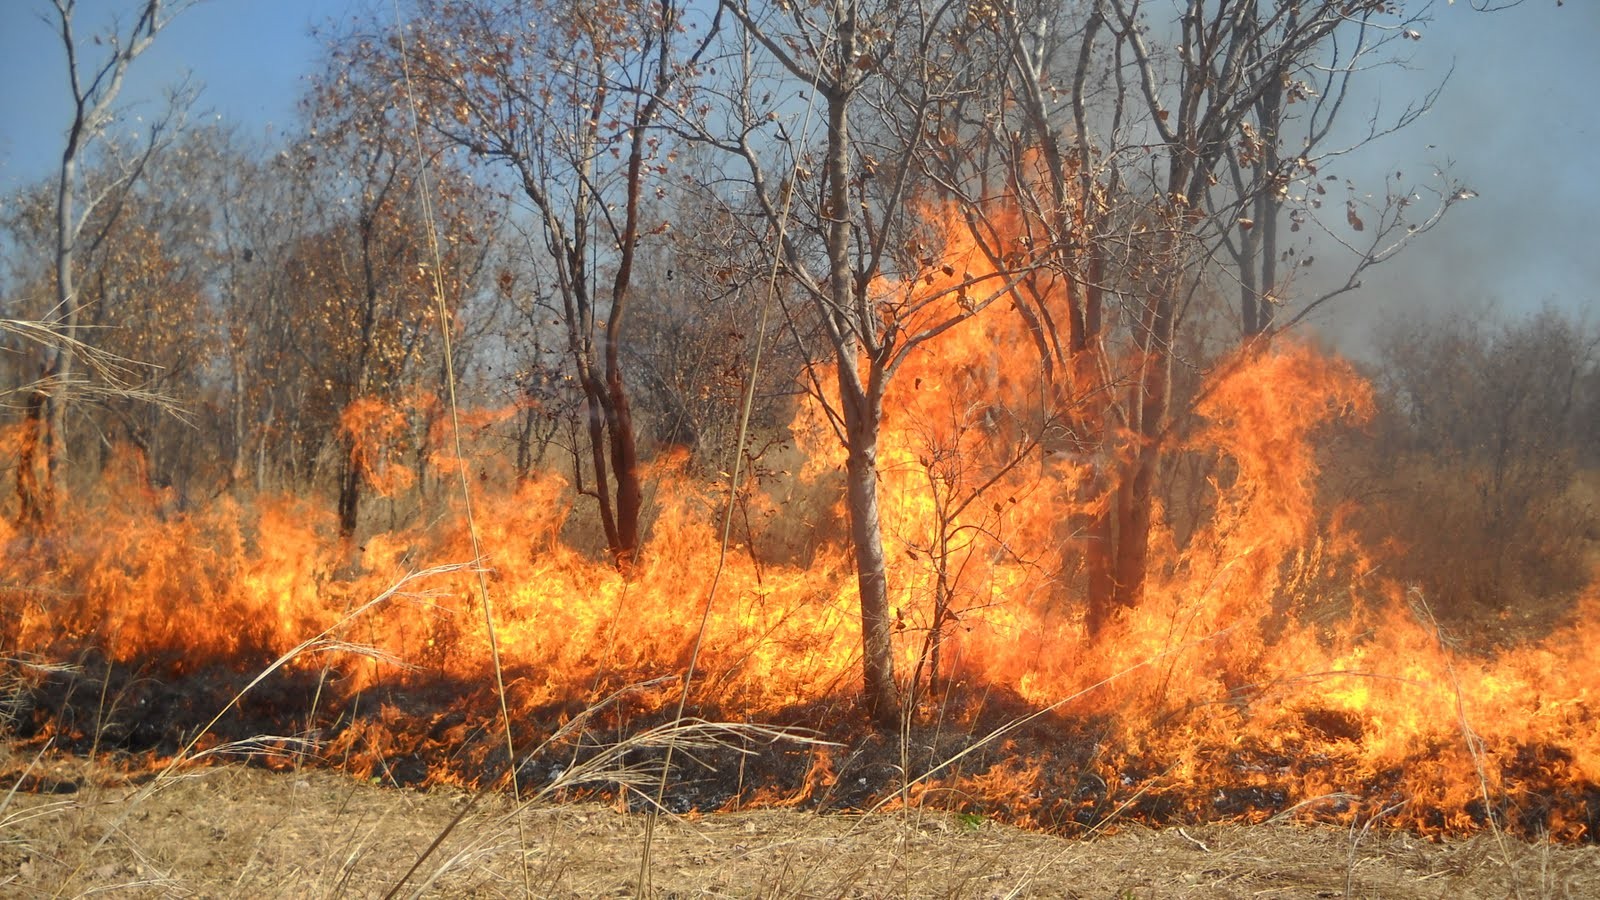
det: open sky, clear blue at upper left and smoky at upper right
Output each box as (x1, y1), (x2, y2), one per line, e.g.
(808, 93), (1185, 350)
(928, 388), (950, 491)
(0, 0), (1600, 343)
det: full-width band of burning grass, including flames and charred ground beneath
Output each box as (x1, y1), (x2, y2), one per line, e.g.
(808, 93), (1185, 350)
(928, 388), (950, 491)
(0, 335), (1600, 842)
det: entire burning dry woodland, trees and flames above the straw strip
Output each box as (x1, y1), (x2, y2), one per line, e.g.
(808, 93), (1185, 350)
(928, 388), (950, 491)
(0, 0), (1600, 895)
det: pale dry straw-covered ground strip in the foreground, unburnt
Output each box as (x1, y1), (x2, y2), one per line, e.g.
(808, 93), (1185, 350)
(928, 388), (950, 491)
(0, 751), (1600, 900)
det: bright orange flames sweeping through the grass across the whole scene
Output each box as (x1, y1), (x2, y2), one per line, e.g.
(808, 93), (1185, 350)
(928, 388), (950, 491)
(0, 203), (1600, 839)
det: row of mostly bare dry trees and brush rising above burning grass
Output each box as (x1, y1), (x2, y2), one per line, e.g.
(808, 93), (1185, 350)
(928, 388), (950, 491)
(0, 0), (1597, 721)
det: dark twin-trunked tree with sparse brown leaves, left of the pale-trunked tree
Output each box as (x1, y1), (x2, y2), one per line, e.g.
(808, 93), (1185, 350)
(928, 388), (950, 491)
(363, 0), (709, 569)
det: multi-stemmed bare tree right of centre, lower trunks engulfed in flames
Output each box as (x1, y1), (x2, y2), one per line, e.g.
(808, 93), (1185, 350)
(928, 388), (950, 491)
(923, 0), (1466, 633)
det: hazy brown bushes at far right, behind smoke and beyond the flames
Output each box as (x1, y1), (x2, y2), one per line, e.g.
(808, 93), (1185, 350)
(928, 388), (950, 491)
(1368, 309), (1600, 612)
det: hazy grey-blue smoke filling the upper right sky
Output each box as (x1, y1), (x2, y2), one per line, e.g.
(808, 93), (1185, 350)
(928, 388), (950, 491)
(1299, 0), (1600, 356)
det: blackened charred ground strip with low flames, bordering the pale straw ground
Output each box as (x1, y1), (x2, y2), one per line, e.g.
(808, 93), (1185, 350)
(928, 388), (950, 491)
(5, 657), (1600, 842)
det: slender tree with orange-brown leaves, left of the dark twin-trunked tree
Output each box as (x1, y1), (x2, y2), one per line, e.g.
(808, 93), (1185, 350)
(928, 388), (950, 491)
(290, 61), (498, 536)
